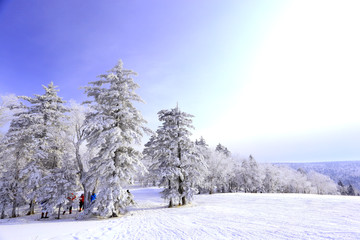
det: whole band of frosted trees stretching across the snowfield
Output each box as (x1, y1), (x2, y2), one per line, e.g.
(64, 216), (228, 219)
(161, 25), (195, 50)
(0, 61), (356, 218)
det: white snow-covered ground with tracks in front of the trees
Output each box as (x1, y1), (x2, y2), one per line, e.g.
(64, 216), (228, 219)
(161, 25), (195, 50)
(0, 188), (360, 240)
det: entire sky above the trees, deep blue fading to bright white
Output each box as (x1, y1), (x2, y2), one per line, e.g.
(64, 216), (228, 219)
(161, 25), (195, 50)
(0, 0), (360, 162)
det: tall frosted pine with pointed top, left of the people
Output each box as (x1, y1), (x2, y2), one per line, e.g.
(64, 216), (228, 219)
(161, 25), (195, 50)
(21, 82), (67, 216)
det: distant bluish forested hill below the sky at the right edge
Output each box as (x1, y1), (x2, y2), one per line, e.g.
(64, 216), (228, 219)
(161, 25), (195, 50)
(285, 161), (360, 190)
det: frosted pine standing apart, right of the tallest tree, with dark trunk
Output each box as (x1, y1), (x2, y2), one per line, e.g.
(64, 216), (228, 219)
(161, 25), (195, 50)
(144, 107), (205, 207)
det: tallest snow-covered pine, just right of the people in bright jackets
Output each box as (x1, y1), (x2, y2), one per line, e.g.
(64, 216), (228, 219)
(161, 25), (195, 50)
(85, 60), (151, 217)
